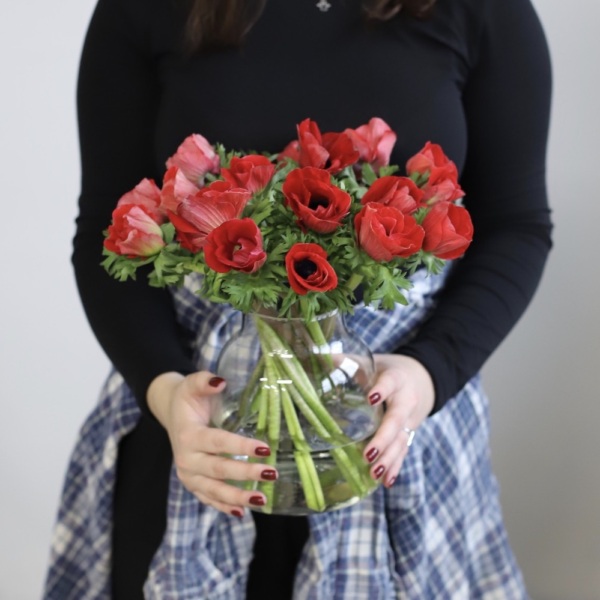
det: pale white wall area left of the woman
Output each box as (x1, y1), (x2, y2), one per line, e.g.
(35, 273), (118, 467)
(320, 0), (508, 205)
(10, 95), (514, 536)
(0, 0), (107, 600)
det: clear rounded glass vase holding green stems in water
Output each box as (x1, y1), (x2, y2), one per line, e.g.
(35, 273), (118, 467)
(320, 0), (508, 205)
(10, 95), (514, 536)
(213, 312), (382, 515)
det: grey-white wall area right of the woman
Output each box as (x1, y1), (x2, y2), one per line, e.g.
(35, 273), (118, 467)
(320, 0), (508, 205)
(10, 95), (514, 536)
(484, 0), (600, 600)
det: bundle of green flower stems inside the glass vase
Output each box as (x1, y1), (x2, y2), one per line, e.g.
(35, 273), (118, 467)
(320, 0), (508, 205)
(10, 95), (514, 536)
(236, 314), (374, 512)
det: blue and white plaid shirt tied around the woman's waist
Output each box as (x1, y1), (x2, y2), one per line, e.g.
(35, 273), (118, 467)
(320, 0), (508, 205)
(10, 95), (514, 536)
(44, 273), (528, 600)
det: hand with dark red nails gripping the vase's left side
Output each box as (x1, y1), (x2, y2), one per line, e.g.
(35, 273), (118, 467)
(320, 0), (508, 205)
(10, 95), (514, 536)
(147, 371), (277, 517)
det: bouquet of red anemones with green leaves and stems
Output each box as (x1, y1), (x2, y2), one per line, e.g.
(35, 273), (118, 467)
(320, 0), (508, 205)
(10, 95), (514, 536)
(103, 118), (473, 511)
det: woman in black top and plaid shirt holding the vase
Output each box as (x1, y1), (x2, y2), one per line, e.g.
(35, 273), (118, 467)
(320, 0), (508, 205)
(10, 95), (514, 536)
(45, 0), (551, 600)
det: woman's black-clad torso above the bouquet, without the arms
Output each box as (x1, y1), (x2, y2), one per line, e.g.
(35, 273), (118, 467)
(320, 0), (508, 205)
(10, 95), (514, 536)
(129, 0), (481, 177)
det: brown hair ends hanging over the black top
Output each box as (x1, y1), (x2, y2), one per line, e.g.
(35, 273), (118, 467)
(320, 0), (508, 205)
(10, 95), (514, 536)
(186, 0), (436, 52)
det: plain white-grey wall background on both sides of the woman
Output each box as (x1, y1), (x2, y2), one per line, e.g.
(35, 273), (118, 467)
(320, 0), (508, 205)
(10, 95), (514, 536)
(0, 0), (600, 600)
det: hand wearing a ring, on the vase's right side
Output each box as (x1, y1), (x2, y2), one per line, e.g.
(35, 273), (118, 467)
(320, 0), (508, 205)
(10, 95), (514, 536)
(364, 354), (435, 487)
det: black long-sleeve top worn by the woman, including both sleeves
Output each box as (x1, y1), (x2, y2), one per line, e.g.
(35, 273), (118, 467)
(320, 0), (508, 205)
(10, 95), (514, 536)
(73, 0), (551, 410)
